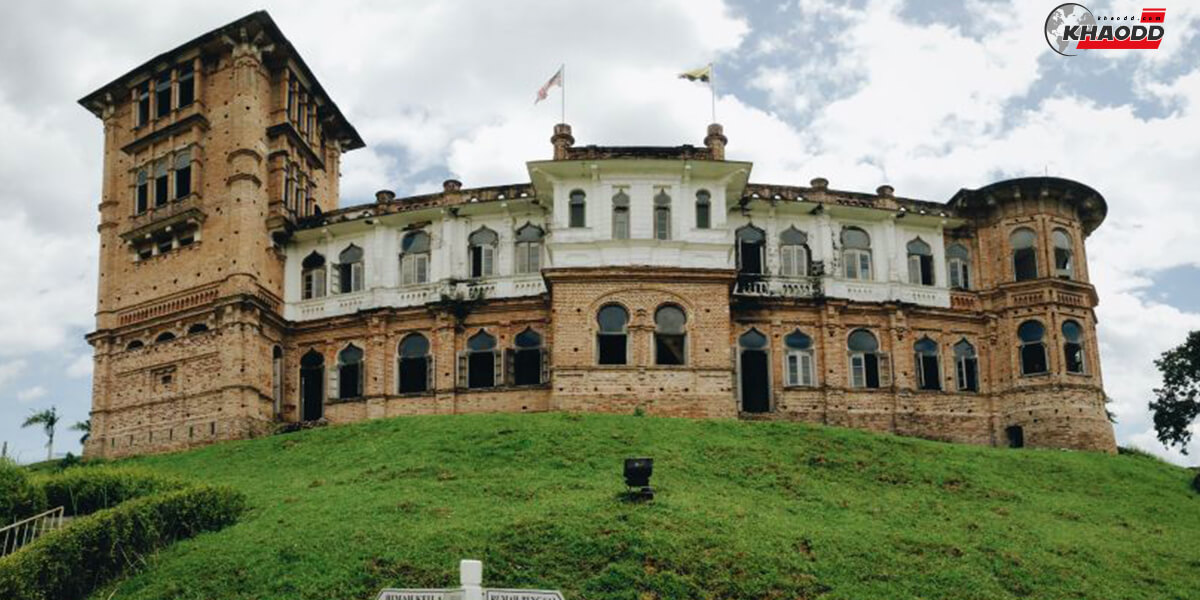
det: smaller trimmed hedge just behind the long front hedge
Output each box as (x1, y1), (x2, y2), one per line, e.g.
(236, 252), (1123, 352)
(37, 467), (185, 515)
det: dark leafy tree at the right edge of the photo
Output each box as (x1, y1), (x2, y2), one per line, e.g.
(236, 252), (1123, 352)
(1150, 331), (1200, 454)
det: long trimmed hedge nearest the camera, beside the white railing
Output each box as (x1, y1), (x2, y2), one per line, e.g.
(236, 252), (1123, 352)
(0, 486), (246, 600)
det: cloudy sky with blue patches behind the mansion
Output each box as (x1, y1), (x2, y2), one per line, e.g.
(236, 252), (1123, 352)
(0, 0), (1200, 463)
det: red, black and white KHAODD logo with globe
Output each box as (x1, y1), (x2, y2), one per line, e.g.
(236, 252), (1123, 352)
(1046, 2), (1166, 56)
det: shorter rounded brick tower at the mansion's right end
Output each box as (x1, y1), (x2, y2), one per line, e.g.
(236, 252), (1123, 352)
(947, 178), (1116, 449)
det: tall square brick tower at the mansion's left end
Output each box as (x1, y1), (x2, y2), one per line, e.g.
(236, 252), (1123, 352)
(79, 12), (362, 456)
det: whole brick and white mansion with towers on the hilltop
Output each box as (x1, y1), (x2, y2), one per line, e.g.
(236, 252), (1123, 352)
(80, 12), (1115, 456)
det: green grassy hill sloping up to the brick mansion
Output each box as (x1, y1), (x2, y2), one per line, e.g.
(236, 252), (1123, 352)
(94, 414), (1200, 600)
